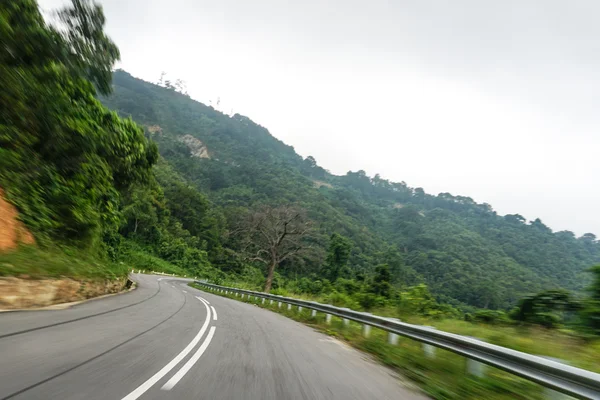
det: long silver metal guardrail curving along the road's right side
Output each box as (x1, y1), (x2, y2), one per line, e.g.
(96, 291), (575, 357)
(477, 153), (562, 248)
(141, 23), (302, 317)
(195, 281), (600, 400)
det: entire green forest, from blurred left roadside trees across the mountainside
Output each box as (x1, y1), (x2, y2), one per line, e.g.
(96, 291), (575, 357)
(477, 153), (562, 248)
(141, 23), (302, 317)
(0, 0), (600, 328)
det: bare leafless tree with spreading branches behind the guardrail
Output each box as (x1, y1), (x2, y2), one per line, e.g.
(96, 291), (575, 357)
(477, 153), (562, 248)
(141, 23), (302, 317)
(236, 206), (312, 293)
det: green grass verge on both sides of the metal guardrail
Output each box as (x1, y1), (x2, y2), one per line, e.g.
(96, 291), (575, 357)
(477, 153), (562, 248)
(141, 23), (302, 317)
(190, 283), (600, 400)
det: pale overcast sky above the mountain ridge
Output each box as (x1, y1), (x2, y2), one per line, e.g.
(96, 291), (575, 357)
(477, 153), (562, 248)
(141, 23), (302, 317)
(40, 0), (600, 234)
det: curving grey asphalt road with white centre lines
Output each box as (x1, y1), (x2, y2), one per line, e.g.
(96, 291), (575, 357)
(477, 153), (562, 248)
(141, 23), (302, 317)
(0, 275), (424, 400)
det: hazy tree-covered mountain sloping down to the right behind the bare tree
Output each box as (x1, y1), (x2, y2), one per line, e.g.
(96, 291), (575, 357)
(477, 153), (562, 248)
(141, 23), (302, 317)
(101, 71), (600, 308)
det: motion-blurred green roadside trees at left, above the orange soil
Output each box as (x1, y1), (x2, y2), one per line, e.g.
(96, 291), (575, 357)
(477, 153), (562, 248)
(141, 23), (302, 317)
(0, 0), (158, 247)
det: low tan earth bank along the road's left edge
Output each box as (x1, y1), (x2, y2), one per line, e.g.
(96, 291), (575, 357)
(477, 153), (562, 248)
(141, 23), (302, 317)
(0, 278), (127, 310)
